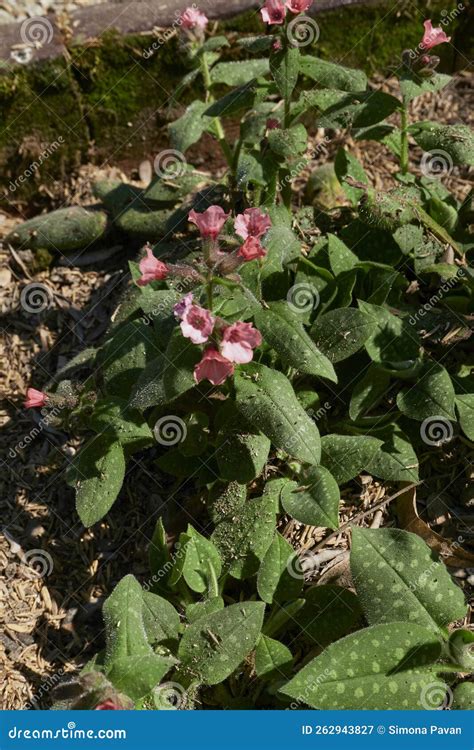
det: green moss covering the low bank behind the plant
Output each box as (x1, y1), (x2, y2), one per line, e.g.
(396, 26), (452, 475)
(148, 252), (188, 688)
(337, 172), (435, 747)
(0, 0), (474, 210)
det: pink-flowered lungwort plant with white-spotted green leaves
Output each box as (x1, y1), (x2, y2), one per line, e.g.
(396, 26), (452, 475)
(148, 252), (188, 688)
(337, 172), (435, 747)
(19, 0), (474, 710)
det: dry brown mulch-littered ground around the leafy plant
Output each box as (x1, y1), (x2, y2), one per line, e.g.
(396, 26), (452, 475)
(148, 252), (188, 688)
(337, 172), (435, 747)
(0, 73), (474, 709)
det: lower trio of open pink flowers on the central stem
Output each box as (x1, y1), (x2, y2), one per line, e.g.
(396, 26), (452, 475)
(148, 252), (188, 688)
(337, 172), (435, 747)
(174, 293), (262, 385)
